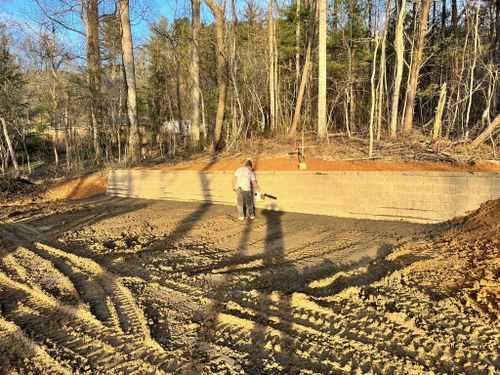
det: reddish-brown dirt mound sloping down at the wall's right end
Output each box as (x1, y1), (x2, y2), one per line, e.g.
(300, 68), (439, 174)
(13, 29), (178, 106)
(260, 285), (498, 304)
(391, 200), (500, 320)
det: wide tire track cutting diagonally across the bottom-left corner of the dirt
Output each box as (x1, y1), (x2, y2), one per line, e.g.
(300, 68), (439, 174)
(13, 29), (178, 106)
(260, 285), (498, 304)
(0, 273), (178, 373)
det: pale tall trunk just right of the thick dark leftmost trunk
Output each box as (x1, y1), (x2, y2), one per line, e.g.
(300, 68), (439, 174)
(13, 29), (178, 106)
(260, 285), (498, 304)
(119, 0), (141, 162)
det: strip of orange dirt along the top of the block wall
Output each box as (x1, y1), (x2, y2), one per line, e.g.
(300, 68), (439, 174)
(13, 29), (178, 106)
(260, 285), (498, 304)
(137, 157), (500, 172)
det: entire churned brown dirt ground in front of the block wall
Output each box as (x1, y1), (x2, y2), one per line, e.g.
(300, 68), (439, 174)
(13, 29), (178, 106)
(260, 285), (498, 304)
(0, 196), (500, 374)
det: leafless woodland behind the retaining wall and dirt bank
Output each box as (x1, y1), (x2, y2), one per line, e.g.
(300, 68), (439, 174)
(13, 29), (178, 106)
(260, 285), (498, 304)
(0, 0), (500, 173)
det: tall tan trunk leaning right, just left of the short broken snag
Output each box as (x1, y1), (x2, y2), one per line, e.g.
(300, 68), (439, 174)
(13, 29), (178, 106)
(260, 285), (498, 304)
(403, 0), (432, 133)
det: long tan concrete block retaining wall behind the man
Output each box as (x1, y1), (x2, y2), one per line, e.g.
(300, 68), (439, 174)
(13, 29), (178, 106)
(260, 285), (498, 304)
(107, 169), (500, 223)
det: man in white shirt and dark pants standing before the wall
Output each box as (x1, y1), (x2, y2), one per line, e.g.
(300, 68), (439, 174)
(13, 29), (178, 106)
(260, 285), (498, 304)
(233, 160), (260, 220)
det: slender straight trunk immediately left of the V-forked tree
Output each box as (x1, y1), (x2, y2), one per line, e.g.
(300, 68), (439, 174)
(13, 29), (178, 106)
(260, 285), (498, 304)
(189, 0), (200, 148)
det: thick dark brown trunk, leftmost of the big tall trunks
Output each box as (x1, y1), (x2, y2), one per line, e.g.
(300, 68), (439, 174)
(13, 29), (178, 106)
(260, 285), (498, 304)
(81, 0), (102, 162)
